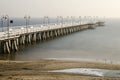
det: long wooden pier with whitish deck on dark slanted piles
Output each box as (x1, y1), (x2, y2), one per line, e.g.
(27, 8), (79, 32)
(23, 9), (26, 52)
(0, 22), (104, 54)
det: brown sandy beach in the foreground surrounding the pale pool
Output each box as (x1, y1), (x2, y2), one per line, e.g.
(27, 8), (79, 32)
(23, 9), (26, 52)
(0, 60), (120, 80)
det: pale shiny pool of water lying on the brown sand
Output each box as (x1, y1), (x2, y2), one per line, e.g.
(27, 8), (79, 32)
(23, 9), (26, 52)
(43, 68), (120, 77)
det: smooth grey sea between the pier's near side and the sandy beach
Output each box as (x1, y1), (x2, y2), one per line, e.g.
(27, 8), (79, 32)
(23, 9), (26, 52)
(1, 19), (120, 63)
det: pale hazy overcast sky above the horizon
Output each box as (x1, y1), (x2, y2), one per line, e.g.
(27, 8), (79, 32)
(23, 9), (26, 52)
(0, 0), (120, 17)
